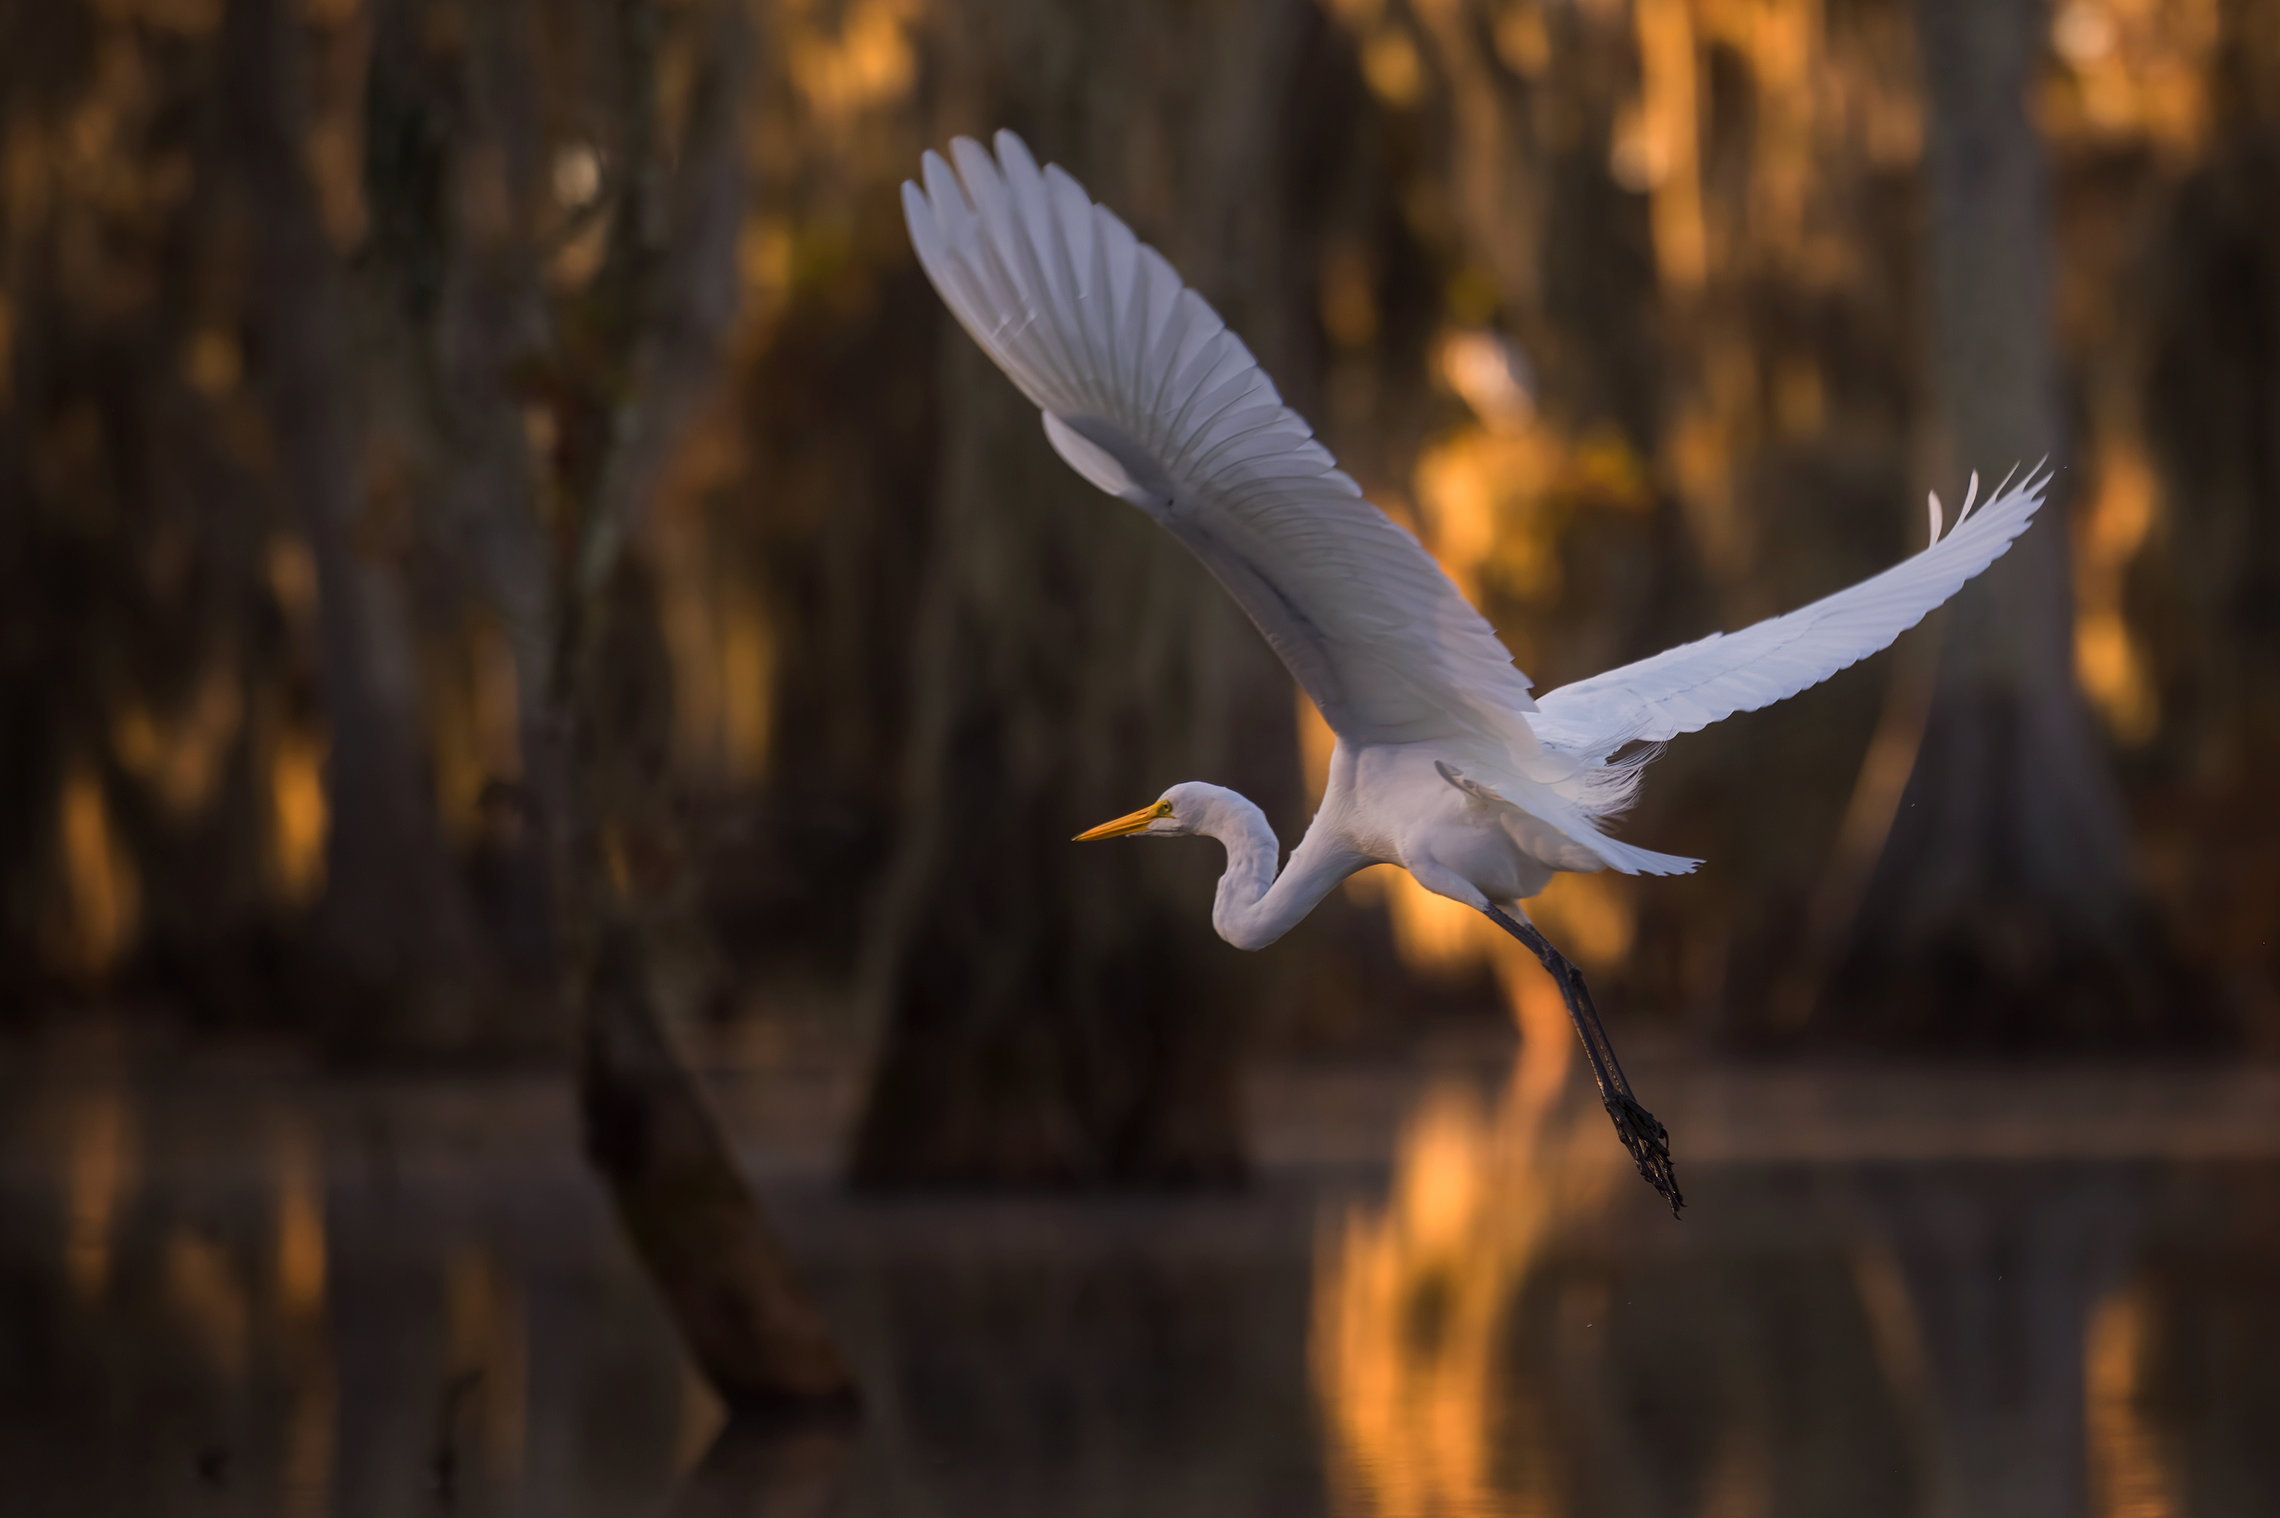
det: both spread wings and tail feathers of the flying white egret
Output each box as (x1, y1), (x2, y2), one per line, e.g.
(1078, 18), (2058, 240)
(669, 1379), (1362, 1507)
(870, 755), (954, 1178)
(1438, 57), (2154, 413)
(903, 132), (2047, 888)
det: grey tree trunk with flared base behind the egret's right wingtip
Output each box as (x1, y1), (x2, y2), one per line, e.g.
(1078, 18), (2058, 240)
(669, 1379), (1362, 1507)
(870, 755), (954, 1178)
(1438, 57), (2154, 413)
(1831, 0), (2161, 1046)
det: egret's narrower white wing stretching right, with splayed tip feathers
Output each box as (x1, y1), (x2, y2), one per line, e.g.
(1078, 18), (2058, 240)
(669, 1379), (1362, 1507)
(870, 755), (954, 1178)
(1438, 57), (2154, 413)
(1530, 470), (2050, 761)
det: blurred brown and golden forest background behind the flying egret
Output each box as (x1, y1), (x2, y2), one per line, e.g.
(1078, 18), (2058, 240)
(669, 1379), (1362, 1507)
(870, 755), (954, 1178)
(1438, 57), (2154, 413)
(0, 0), (2280, 1153)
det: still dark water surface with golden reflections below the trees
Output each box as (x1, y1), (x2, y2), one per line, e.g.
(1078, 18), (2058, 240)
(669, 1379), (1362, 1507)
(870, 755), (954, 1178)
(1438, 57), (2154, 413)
(0, 1030), (2280, 1518)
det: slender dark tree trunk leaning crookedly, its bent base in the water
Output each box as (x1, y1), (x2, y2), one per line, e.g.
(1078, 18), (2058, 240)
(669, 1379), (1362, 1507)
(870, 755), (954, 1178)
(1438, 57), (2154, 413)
(374, 0), (853, 1409)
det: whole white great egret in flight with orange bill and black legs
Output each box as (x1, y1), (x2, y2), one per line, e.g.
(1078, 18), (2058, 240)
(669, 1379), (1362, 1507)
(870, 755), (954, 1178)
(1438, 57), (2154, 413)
(903, 132), (2050, 1213)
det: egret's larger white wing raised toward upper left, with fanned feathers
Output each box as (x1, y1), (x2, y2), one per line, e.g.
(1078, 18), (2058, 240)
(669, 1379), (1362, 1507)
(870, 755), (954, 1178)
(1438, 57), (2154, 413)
(903, 132), (1534, 752)
